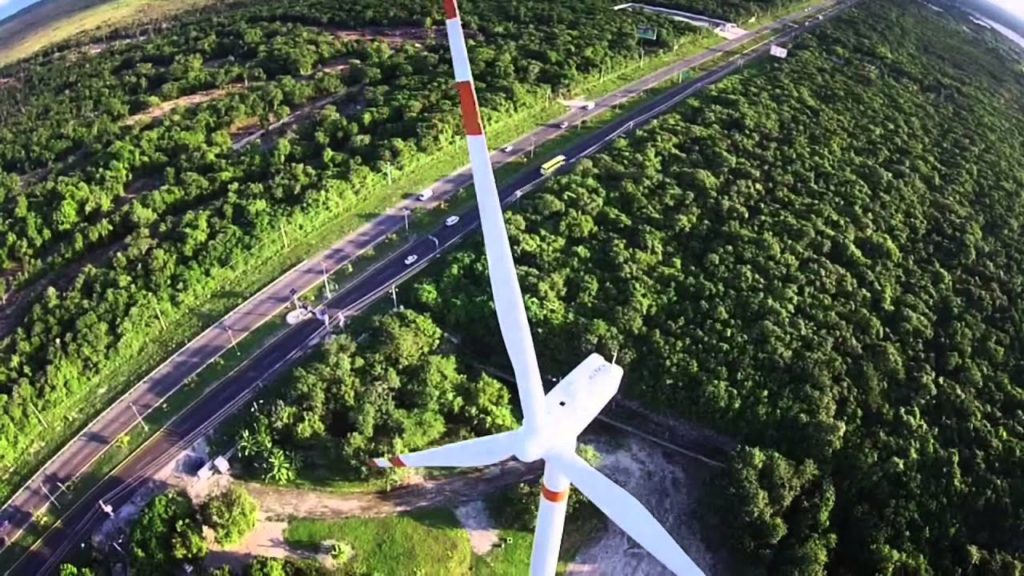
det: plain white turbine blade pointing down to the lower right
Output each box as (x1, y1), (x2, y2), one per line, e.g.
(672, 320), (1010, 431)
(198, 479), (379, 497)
(547, 454), (703, 575)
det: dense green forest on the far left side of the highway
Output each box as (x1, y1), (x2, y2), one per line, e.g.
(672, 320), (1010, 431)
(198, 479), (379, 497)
(0, 0), (720, 497)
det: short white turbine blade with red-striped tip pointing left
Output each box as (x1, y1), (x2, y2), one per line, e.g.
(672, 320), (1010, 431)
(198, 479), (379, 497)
(370, 430), (519, 468)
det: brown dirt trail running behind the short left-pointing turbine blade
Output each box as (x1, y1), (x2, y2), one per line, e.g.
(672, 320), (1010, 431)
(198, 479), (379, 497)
(245, 461), (542, 519)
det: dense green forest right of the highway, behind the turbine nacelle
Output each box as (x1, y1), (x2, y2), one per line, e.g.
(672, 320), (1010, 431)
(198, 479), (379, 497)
(405, 0), (1024, 574)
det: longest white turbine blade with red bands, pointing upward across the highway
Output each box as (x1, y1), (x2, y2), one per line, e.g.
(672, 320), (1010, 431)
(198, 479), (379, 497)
(444, 0), (544, 430)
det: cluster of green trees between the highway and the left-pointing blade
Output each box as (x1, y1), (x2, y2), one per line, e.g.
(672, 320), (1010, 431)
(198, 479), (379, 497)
(237, 311), (517, 484)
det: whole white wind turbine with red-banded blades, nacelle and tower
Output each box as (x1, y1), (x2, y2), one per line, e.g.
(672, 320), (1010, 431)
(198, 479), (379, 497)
(372, 0), (702, 576)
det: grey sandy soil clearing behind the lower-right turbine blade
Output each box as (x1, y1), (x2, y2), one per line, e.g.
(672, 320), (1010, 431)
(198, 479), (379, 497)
(566, 437), (717, 576)
